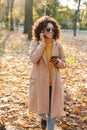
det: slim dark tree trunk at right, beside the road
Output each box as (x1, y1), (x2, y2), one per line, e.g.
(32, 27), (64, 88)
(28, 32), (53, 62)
(74, 0), (81, 36)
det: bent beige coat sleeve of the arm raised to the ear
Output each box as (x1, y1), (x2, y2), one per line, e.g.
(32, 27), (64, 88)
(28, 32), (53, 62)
(29, 40), (46, 63)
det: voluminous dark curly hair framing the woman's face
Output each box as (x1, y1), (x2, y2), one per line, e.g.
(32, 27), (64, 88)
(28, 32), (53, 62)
(32, 16), (60, 41)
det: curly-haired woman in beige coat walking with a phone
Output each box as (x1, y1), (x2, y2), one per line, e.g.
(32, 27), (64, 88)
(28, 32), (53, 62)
(29, 16), (66, 130)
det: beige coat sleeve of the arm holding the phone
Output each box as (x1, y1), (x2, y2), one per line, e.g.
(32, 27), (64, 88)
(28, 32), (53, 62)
(56, 44), (66, 69)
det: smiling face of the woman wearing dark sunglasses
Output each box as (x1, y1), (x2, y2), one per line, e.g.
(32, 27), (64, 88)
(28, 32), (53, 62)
(44, 23), (54, 38)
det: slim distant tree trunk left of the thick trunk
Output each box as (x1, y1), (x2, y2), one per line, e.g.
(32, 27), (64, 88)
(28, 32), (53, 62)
(10, 0), (14, 31)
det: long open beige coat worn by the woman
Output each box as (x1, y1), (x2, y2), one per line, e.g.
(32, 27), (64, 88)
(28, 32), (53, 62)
(29, 40), (66, 118)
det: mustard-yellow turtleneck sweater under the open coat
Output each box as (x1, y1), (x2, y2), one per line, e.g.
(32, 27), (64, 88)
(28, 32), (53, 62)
(45, 38), (53, 86)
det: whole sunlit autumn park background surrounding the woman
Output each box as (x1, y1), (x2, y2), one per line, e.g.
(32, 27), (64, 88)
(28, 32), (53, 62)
(0, 0), (87, 130)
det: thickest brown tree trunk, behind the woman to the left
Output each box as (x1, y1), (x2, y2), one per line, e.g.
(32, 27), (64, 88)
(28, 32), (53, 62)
(24, 0), (33, 39)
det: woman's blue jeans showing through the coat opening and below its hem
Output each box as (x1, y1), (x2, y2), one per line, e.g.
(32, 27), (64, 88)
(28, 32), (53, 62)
(42, 86), (55, 130)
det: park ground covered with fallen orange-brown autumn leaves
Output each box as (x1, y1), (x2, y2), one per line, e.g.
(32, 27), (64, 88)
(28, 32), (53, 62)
(0, 31), (87, 130)
